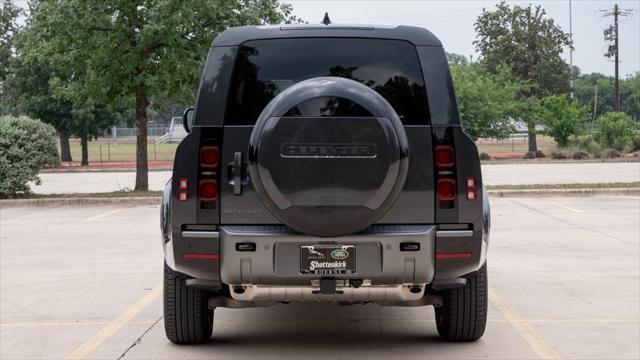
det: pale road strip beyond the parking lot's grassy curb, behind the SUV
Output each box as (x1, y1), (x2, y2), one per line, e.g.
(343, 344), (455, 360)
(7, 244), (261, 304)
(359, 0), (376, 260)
(31, 162), (640, 194)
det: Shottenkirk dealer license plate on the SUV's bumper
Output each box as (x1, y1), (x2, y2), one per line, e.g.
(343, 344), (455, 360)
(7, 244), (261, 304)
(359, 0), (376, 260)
(300, 244), (356, 275)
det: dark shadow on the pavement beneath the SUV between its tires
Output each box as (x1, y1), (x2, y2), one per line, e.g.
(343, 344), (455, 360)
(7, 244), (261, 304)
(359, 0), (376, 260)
(198, 303), (482, 359)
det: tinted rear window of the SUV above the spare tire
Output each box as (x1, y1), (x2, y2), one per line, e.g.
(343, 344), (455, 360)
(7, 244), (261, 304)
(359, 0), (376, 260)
(225, 38), (429, 125)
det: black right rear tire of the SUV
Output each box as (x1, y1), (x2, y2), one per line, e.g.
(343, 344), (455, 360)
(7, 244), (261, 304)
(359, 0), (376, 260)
(435, 263), (488, 341)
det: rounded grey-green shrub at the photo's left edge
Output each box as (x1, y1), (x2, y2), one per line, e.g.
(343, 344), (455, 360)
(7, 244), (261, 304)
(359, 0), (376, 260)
(0, 116), (58, 196)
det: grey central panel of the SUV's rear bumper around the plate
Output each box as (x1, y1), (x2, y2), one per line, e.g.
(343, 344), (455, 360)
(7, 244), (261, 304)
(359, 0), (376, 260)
(219, 225), (436, 286)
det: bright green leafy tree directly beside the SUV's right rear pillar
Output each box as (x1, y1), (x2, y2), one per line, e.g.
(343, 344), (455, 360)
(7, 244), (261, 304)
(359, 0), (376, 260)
(451, 64), (522, 140)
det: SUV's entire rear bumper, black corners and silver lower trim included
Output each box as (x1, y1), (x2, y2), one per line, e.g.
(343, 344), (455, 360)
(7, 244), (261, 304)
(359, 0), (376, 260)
(163, 224), (488, 302)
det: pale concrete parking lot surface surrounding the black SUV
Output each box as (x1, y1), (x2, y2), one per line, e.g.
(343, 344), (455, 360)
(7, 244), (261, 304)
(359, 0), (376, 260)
(0, 196), (640, 359)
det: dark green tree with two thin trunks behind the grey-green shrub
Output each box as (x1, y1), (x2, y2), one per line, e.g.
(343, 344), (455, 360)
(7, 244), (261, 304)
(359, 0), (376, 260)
(6, 2), (121, 165)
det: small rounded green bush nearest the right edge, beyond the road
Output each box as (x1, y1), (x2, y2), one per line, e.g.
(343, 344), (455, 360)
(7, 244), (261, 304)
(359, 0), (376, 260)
(597, 112), (634, 151)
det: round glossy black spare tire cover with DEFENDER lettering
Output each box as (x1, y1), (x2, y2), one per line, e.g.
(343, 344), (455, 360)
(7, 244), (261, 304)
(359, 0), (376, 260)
(248, 77), (409, 236)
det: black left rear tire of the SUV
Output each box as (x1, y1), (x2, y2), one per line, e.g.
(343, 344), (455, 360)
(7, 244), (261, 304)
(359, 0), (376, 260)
(164, 263), (213, 344)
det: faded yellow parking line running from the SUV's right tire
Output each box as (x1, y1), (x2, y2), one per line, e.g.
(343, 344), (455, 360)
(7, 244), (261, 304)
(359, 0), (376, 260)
(489, 288), (560, 359)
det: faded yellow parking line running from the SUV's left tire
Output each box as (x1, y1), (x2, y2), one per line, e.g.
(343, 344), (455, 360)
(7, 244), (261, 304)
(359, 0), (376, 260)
(66, 284), (162, 359)
